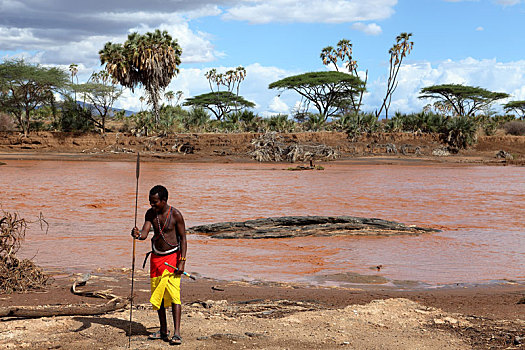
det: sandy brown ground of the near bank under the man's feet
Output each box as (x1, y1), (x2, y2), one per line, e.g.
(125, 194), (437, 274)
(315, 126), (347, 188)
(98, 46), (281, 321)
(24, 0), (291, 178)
(0, 269), (525, 350)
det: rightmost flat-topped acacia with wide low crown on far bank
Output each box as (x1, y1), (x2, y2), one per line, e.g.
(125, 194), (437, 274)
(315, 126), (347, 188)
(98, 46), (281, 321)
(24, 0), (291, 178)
(419, 84), (509, 117)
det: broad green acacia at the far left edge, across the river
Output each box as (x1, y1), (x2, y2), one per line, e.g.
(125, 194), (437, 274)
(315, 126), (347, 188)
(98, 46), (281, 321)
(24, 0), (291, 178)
(0, 60), (69, 136)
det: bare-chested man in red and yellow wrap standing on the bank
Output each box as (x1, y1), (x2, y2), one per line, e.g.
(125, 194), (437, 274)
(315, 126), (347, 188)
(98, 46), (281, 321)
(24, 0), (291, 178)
(131, 185), (187, 345)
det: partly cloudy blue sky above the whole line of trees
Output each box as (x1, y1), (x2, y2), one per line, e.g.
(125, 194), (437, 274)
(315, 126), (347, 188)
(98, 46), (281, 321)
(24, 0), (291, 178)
(0, 0), (525, 115)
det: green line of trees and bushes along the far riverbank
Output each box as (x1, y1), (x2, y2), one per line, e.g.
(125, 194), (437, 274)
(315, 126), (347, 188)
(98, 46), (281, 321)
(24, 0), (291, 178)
(0, 30), (525, 147)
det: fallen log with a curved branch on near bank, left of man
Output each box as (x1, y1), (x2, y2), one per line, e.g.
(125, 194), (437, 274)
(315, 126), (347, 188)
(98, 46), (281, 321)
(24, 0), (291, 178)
(0, 275), (128, 318)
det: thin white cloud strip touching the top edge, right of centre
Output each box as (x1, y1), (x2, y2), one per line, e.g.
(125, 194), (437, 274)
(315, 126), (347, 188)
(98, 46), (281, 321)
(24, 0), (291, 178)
(223, 0), (397, 23)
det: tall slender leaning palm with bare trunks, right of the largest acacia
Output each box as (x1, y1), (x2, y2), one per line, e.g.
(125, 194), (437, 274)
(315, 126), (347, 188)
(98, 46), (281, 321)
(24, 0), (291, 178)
(376, 33), (414, 119)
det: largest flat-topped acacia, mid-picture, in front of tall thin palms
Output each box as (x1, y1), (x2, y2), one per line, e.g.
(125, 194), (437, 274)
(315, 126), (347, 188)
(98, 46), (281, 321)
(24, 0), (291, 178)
(269, 71), (365, 122)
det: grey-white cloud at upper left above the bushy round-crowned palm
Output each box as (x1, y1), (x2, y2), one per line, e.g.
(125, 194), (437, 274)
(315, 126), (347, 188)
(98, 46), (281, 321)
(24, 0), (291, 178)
(0, 0), (229, 66)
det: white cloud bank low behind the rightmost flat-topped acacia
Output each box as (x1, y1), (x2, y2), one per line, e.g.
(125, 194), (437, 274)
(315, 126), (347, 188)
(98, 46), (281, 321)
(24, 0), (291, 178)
(364, 58), (525, 112)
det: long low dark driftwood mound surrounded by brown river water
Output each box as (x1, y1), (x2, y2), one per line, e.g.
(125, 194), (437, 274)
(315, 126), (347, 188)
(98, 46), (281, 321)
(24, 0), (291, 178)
(187, 216), (439, 239)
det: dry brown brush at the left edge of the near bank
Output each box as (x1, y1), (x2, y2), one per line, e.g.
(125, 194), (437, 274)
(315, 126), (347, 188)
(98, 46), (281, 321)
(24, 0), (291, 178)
(0, 211), (49, 294)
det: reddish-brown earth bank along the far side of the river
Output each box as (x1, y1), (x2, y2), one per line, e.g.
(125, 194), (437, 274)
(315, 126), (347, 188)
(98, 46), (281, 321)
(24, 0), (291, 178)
(0, 132), (525, 165)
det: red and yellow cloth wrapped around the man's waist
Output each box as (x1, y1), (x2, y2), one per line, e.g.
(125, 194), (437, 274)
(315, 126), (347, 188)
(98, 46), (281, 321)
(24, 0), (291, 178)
(149, 252), (180, 310)
